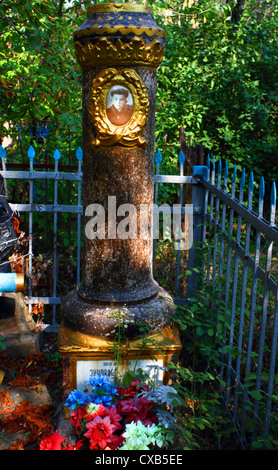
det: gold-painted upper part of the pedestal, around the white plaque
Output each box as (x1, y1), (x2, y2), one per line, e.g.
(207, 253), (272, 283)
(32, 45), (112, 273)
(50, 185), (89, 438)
(58, 325), (182, 398)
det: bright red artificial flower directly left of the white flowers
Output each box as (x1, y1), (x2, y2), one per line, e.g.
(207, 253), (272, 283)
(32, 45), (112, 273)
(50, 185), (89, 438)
(84, 416), (116, 450)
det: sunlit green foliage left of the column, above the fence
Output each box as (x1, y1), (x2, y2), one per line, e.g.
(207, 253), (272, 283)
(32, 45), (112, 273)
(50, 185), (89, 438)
(0, 0), (84, 153)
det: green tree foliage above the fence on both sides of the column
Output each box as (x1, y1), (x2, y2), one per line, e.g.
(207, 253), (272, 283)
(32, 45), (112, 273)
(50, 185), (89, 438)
(0, 0), (278, 184)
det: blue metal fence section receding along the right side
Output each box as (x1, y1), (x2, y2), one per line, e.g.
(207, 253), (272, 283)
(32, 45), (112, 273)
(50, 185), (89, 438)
(192, 155), (278, 445)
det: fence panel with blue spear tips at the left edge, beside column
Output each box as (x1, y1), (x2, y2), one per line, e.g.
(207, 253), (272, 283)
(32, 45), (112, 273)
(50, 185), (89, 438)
(0, 146), (83, 330)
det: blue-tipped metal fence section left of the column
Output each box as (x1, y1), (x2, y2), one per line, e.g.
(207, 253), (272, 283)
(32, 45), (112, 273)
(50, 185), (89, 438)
(0, 146), (83, 329)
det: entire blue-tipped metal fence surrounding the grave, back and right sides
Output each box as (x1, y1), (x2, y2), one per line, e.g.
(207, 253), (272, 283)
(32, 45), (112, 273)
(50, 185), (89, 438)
(0, 141), (278, 446)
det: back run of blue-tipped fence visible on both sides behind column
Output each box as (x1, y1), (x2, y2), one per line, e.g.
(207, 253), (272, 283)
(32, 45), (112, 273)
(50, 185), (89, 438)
(0, 142), (195, 324)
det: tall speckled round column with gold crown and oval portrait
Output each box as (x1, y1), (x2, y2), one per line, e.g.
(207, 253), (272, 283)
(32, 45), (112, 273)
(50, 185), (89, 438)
(59, 3), (174, 344)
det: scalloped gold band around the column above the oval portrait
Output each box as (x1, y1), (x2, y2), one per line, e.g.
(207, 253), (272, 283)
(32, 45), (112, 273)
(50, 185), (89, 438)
(75, 37), (165, 70)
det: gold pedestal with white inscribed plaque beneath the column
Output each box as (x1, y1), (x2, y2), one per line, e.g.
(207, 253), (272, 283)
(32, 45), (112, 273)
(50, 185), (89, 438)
(60, 326), (180, 398)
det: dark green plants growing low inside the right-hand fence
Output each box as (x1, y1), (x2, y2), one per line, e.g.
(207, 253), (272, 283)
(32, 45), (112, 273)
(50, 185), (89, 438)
(165, 241), (239, 450)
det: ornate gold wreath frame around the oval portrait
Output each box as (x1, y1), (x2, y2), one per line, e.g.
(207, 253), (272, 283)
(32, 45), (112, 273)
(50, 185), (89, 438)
(89, 68), (149, 148)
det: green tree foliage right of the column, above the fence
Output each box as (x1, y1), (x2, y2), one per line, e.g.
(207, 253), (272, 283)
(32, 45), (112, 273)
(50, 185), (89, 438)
(151, 0), (278, 182)
